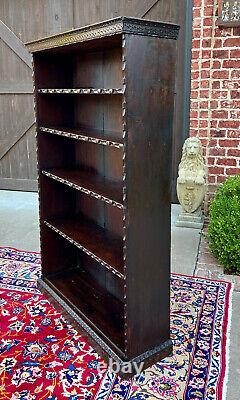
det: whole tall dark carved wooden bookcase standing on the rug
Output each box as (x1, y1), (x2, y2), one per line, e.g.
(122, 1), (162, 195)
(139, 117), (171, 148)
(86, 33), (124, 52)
(27, 17), (179, 372)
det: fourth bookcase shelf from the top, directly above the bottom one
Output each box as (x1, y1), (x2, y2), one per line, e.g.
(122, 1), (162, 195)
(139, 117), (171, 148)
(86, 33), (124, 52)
(44, 217), (124, 278)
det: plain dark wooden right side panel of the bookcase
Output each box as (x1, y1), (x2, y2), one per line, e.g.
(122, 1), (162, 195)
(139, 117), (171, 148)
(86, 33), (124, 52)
(125, 35), (176, 359)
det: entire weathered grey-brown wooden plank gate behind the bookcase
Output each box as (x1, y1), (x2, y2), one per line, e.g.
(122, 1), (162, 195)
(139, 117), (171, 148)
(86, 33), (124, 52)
(0, 0), (192, 202)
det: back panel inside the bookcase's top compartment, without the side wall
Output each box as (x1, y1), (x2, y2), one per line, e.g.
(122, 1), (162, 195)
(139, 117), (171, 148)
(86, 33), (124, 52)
(73, 48), (122, 88)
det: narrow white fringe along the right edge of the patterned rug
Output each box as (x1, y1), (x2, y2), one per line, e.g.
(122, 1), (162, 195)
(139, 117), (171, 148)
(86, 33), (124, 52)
(222, 283), (234, 400)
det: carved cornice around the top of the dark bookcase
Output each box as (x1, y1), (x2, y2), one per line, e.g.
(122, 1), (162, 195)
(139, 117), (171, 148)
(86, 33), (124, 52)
(26, 17), (179, 52)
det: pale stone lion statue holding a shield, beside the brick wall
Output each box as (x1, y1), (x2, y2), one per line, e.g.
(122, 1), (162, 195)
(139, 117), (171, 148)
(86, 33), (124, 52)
(176, 137), (206, 228)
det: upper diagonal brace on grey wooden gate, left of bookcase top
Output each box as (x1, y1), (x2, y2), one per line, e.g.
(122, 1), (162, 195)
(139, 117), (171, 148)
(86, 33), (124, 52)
(0, 20), (32, 69)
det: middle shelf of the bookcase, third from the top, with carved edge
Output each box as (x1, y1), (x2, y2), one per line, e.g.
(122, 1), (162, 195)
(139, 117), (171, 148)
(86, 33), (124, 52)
(42, 168), (123, 209)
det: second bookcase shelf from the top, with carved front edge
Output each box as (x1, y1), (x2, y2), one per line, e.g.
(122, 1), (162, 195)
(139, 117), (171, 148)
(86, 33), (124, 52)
(39, 126), (123, 148)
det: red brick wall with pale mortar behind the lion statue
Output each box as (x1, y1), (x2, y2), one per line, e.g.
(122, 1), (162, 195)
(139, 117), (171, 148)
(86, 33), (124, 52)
(190, 0), (240, 206)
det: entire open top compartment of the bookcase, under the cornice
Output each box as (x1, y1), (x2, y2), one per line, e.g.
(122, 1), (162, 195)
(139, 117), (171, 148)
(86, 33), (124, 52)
(35, 42), (122, 89)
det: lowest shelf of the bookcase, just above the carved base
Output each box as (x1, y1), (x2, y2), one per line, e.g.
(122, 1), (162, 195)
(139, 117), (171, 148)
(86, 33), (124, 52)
(44, 268), (124, 348)
